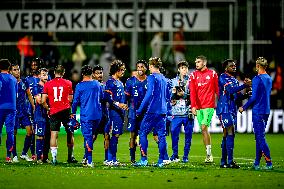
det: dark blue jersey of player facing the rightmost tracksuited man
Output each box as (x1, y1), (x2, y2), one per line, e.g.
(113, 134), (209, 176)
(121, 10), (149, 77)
(216, 73), (247, 115)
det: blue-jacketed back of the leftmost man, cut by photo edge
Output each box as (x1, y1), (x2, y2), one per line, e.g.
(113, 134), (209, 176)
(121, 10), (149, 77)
(0, 73), (17, 110)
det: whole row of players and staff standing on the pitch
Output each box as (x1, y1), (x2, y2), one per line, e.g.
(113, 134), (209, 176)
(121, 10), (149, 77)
(0, 55), (272, 169)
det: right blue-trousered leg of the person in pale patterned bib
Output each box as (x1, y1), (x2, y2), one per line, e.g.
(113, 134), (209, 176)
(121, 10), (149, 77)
(182, 117), (194, 163)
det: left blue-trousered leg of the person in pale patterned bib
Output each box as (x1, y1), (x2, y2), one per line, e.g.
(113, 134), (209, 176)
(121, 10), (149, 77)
(171, 117), (183, 162)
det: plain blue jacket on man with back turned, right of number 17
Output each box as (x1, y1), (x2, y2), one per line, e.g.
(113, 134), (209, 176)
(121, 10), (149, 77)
(72, 80), (103, 121)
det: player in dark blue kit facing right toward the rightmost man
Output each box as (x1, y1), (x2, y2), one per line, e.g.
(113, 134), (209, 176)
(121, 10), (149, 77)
(216, 59), (251, 169)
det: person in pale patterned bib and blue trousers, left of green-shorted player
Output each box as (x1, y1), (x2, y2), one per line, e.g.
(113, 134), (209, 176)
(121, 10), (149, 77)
(171, 61), (194, 163)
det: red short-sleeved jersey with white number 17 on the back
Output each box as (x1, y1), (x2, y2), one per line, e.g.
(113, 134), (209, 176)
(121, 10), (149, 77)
(43, 78), (73, 115)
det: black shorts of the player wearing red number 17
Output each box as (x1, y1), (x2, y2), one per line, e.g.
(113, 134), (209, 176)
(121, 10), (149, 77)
(49, 109), (70, 131)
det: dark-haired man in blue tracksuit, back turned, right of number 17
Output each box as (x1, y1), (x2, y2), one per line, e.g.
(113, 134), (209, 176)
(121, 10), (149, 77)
(72, 65), (103, 167)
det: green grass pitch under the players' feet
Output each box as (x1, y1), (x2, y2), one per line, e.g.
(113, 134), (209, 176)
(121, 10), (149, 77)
(0, 132), (284, 189)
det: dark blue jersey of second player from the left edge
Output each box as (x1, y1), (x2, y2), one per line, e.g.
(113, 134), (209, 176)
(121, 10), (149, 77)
(17, 79), (30, 117)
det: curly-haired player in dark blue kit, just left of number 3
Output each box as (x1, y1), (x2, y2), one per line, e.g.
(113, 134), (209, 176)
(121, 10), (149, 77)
(105, 60), (128, 166)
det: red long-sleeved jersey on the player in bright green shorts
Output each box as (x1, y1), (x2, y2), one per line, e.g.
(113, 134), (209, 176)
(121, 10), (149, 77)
(189, 69), (219, 110)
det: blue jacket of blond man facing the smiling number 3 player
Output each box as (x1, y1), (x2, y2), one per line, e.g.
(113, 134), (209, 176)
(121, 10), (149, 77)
(136, 73), (170, 115)
